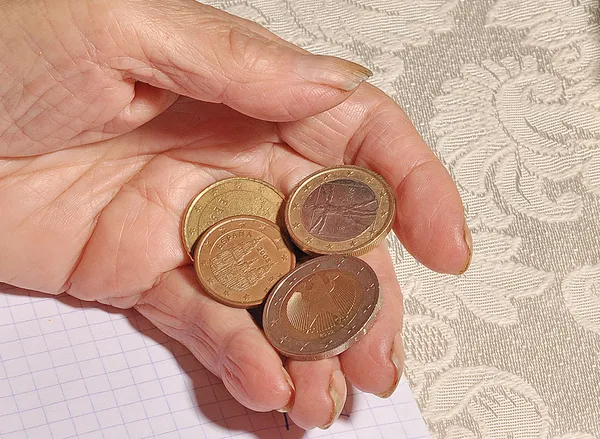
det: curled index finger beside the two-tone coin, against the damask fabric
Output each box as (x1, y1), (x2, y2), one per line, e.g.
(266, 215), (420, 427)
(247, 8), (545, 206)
(280, 84), (472, 274)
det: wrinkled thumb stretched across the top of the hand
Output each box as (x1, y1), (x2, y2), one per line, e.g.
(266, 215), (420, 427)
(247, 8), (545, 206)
(95, 0), (372, 121)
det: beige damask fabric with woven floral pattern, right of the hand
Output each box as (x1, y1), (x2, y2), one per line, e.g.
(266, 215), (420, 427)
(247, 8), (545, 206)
(206, 0), (600, 439)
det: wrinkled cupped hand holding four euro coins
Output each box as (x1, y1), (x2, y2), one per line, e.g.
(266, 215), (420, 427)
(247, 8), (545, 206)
(0, 0), (470, 428)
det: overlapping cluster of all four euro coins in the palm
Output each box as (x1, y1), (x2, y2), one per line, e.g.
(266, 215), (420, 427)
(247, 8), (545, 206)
(182, 166), (395, 360)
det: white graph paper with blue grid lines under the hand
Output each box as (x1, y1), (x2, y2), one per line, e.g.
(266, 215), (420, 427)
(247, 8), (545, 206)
(0, 287), (430, 439)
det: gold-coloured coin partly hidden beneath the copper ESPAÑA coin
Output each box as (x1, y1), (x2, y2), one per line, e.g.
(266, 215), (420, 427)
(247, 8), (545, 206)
(181, 177), (284, 256)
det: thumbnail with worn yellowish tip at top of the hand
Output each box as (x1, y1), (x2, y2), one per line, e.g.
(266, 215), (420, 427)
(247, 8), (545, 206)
(298, 55), (373, 91)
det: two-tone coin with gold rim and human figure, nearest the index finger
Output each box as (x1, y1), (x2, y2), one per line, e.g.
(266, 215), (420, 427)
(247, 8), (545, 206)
(285, 166), (396, 256)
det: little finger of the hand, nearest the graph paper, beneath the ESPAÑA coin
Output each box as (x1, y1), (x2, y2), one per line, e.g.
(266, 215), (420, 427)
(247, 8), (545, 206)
(135, 266), (294, 411)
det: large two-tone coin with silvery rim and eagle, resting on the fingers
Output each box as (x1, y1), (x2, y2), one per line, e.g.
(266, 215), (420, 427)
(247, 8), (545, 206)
(263, 255), (380, 360)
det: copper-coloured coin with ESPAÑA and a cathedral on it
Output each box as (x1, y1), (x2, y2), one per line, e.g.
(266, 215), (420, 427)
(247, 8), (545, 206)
(194, 216), (296, 308)
